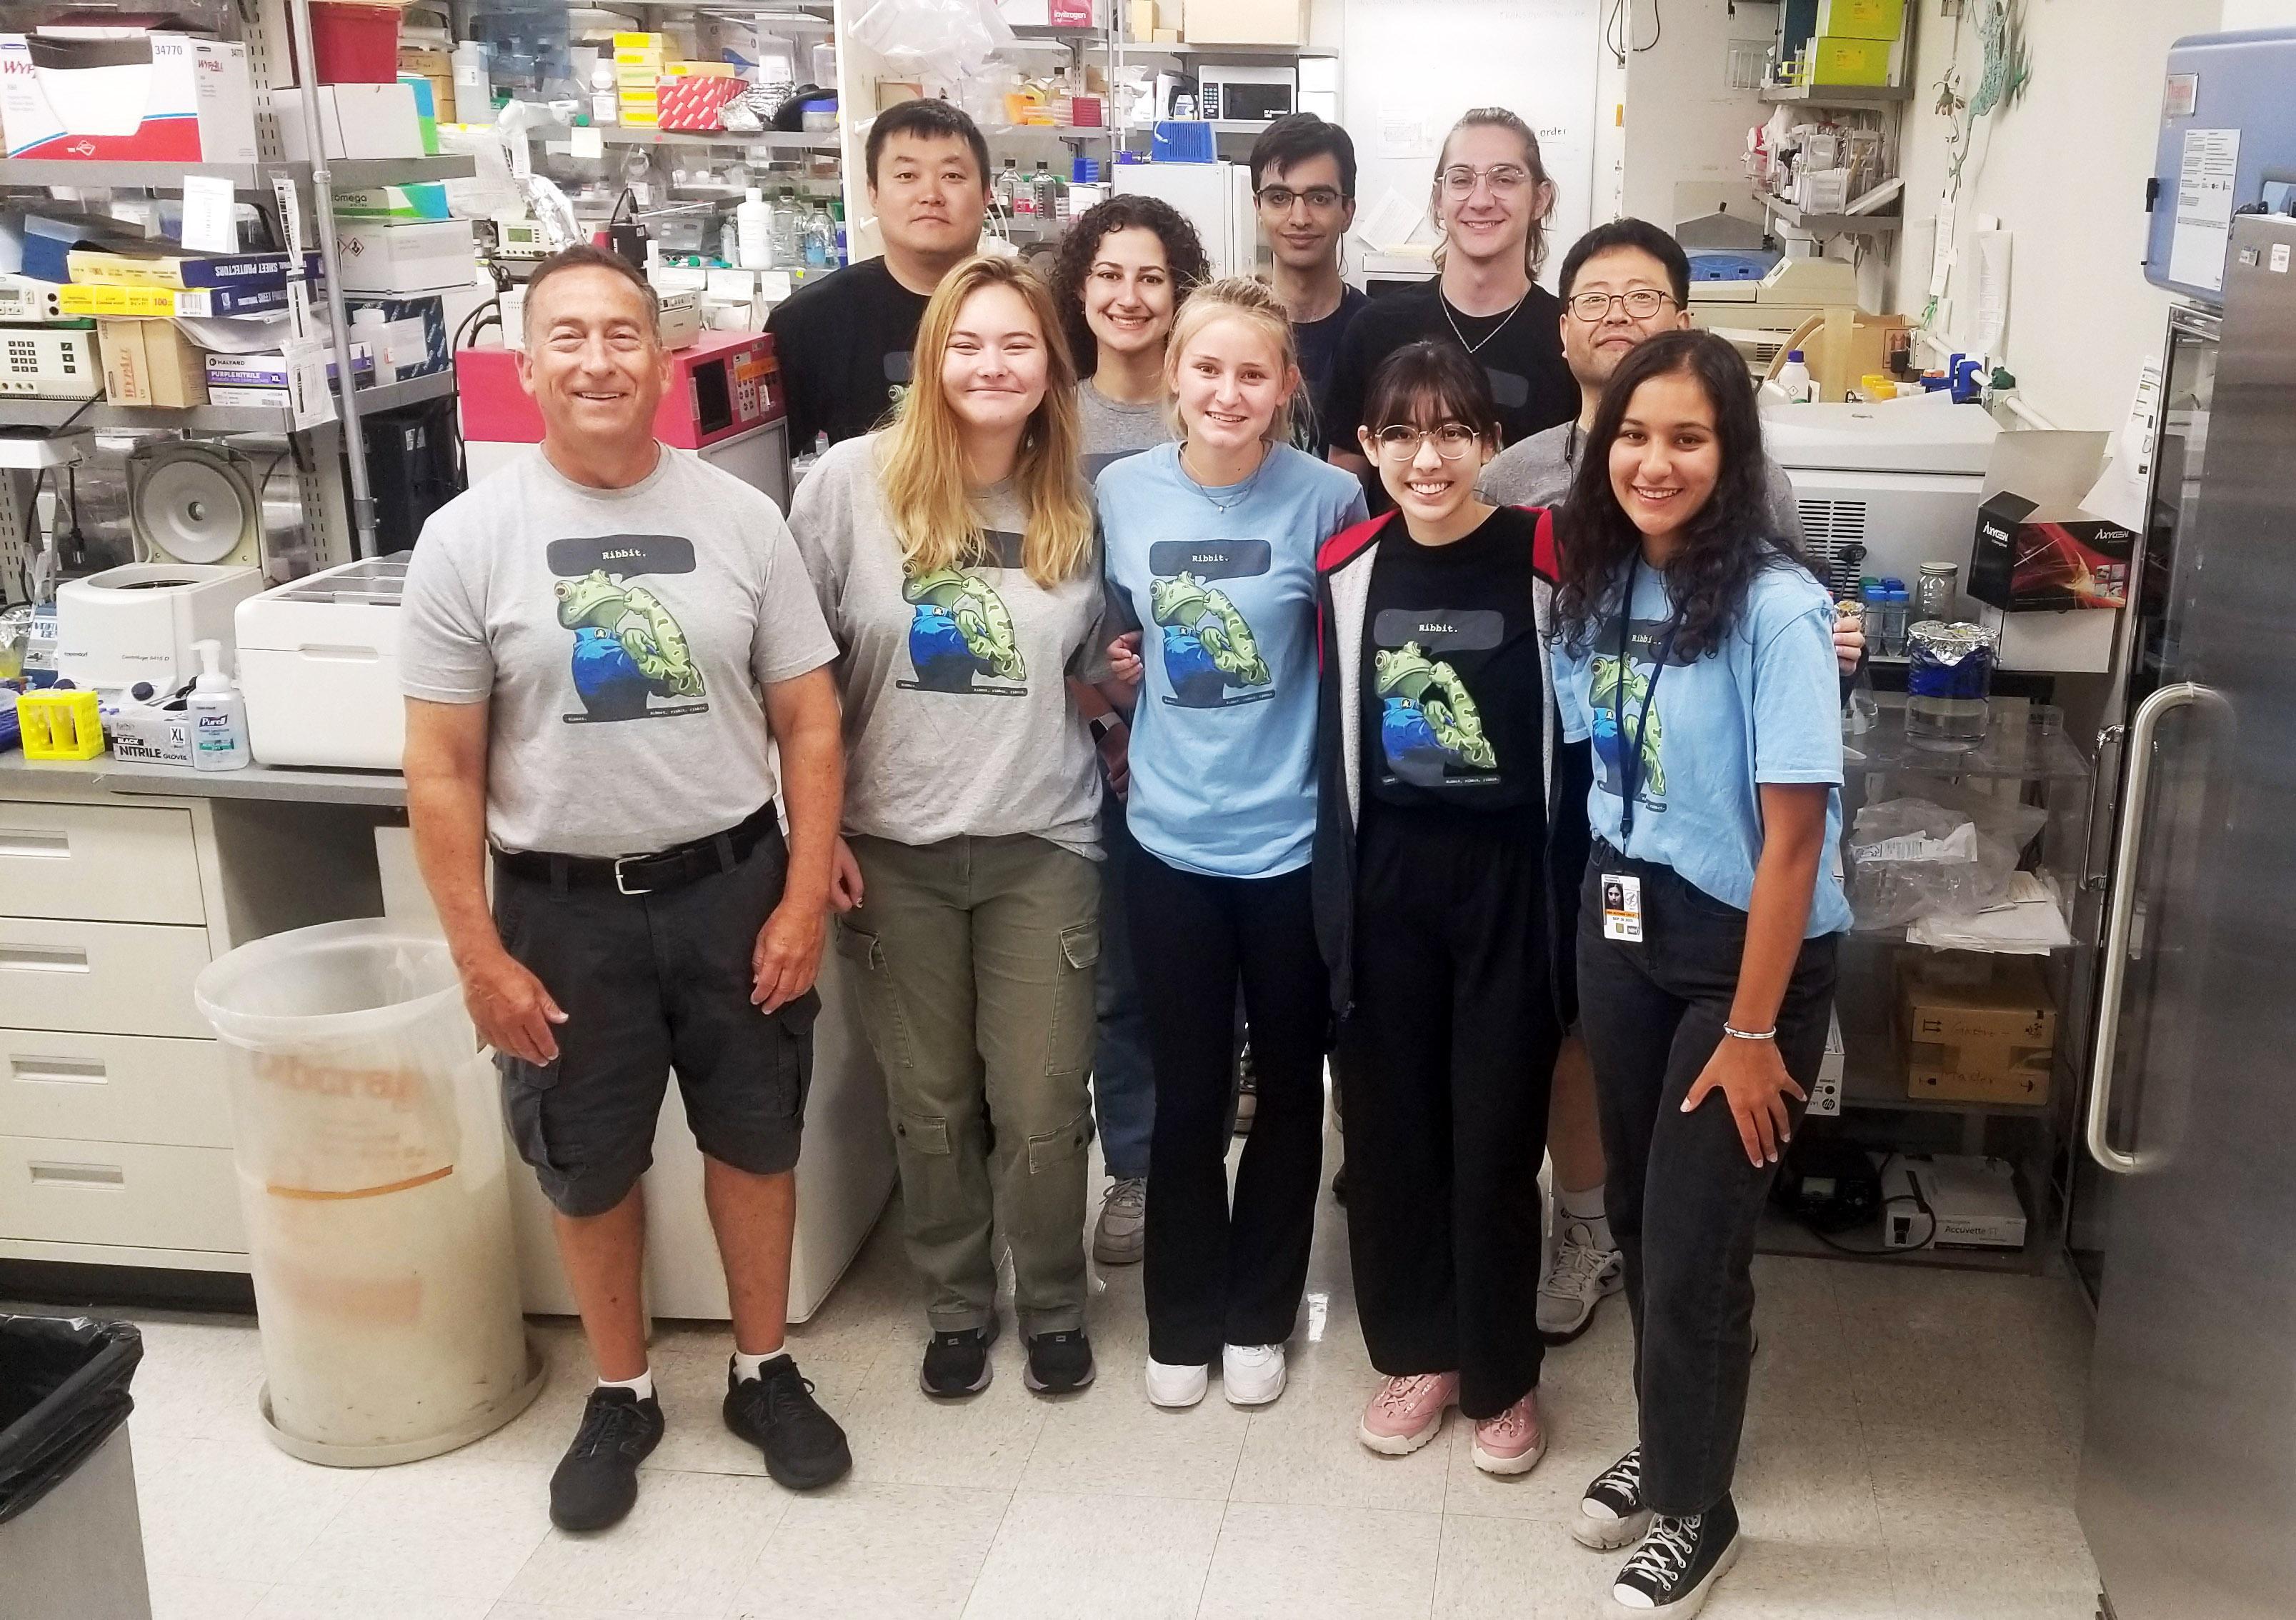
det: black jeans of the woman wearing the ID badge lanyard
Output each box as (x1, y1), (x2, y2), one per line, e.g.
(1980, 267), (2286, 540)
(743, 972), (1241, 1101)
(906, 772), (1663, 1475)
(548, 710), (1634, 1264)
(1577, 840), (1839, 1514)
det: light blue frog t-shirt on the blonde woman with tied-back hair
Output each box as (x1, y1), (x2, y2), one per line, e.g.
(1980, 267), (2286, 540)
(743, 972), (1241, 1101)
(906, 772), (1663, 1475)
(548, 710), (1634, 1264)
(1095, 445), (1364, 876)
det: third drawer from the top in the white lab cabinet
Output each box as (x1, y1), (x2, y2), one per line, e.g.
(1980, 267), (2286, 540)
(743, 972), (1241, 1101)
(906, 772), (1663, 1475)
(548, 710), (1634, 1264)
(0, 1030), (232, 1147)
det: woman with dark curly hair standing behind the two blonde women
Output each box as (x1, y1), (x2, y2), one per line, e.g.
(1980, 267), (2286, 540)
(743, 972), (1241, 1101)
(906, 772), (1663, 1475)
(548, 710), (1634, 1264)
(1052, 195), (1205, 1266)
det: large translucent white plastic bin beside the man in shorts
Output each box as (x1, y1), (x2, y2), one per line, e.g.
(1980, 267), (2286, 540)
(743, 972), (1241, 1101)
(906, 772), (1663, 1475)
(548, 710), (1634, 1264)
(193, 918), (544, 1466)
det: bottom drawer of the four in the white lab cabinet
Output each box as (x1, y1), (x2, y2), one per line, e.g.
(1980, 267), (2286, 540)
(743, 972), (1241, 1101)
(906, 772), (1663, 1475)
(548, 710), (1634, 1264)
(0, 1136), (248, 1253)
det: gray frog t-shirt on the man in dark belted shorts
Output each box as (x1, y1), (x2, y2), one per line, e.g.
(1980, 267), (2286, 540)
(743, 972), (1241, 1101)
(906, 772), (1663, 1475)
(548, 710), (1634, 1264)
(399, 445), (838, 856)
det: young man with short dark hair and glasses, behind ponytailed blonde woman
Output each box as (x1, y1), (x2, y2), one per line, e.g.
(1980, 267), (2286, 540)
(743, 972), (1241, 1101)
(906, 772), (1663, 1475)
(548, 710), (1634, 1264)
(1252, 112), (1366, 450)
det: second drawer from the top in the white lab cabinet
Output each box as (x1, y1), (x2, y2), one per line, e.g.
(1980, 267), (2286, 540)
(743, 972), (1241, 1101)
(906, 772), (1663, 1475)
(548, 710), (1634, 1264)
(0, 916), (211, 1037)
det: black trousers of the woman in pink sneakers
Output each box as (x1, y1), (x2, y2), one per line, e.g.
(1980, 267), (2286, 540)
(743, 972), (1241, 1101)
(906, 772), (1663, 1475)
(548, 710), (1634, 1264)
(1332, 803), (1562, 1418)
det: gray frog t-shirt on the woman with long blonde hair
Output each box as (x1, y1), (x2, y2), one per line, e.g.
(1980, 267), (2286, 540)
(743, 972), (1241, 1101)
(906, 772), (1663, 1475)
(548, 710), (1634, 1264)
(790, 434), (1109, 858)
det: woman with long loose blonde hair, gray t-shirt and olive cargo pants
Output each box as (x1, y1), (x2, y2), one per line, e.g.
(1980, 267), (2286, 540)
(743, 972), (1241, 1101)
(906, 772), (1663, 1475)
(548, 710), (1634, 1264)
(790, 255), (1107, 1395)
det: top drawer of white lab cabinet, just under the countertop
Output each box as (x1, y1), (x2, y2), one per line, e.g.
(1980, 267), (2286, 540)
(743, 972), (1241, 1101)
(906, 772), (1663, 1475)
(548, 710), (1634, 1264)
(0, 799), (206, 922)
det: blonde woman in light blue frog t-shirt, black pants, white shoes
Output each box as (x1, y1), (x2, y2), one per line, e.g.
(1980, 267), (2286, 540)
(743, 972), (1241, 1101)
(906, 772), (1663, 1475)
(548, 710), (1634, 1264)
(1097, 278), (1364, 1406)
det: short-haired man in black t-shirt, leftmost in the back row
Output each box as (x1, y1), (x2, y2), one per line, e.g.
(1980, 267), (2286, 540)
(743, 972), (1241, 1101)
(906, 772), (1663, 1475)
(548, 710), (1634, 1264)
(764, 99), (989, 454)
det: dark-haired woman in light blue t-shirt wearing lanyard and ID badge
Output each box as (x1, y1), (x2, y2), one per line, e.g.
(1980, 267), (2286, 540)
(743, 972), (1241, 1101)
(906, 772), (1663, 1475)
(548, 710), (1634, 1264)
(1554, 333), (1850, 1616)
